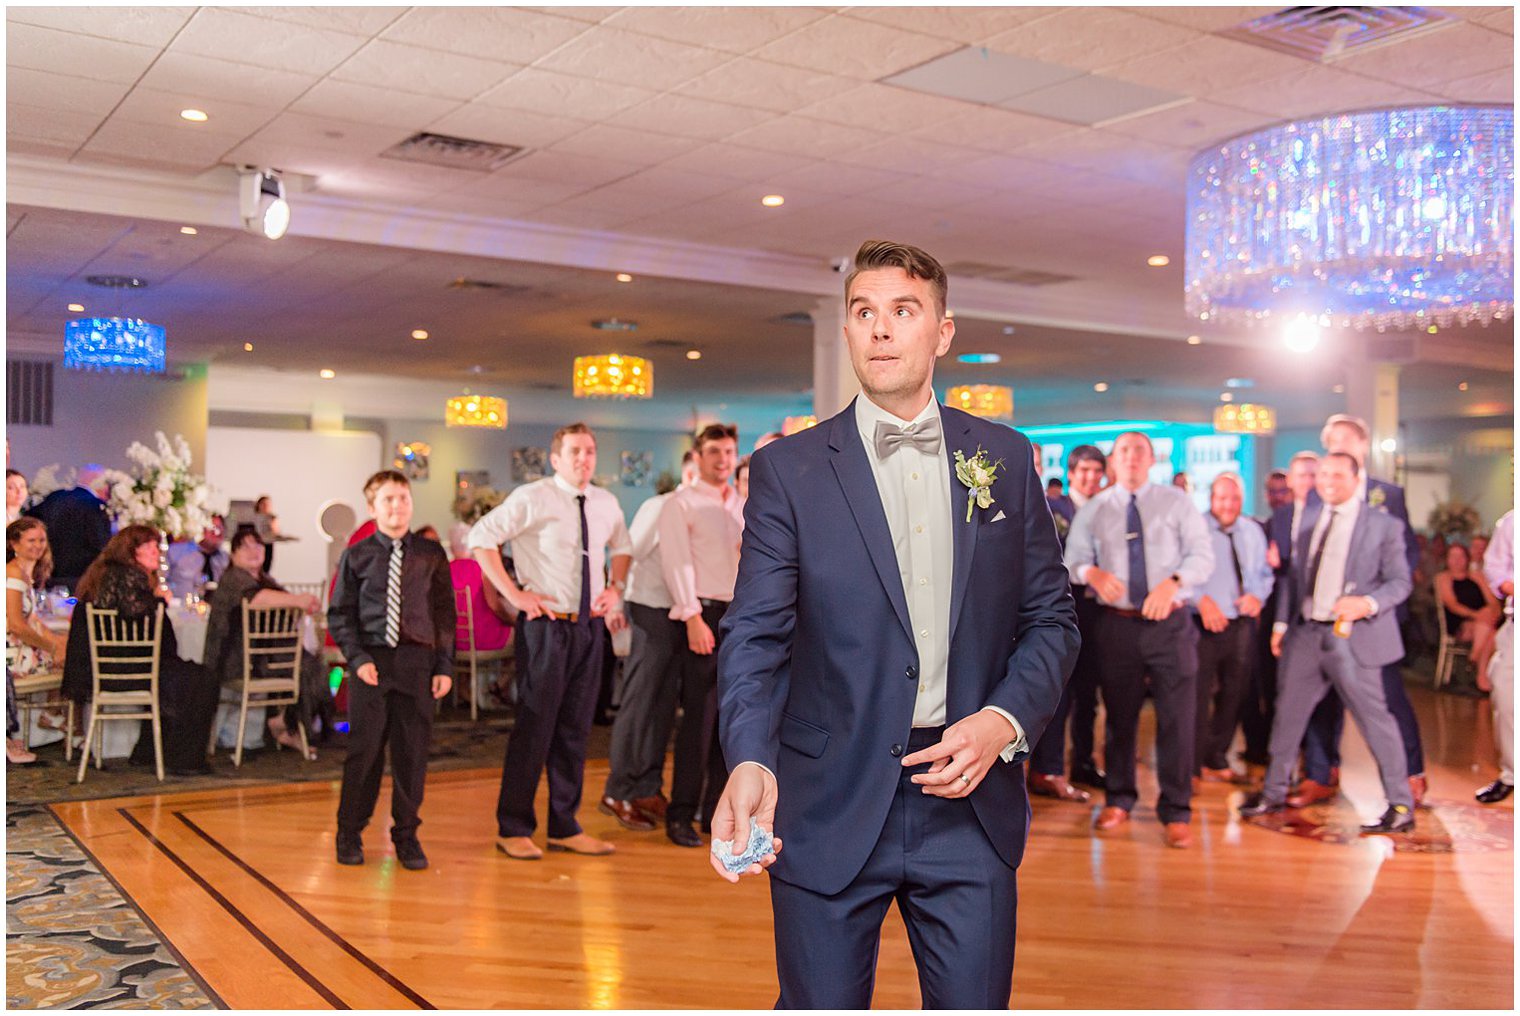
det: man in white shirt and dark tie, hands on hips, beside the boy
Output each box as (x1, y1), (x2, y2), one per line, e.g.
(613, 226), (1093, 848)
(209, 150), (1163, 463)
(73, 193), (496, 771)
(470, 423), (632, 861)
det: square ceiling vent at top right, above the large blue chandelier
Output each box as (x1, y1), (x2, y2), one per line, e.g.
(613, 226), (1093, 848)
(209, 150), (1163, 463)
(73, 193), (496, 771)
(1219, 8), (1456, 62)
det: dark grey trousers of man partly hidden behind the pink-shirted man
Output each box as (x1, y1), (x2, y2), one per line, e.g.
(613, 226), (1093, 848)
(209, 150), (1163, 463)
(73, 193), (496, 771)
(603, 602), (689, 800)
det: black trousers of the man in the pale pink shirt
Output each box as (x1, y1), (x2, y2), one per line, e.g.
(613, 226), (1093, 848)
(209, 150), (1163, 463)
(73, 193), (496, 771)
(666, 601), (728, 823)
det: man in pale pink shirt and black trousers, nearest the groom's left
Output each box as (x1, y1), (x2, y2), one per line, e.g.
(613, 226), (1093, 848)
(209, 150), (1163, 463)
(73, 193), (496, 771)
(660, 423), (745, 847)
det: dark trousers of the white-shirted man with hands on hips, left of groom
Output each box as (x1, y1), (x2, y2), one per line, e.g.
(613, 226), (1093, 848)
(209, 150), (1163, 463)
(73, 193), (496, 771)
(496, 616), (605, 840)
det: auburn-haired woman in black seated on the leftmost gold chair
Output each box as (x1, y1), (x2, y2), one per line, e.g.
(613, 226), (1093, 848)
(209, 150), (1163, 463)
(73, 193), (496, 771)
(64, 525), (217, 776)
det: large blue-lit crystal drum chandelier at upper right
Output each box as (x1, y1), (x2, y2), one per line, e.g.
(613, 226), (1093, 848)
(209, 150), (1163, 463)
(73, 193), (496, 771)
(1186, 106), (1514, 330)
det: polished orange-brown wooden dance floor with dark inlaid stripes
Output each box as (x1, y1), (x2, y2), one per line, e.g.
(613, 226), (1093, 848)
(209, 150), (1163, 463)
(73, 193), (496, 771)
(44, 697), (1514, 1008)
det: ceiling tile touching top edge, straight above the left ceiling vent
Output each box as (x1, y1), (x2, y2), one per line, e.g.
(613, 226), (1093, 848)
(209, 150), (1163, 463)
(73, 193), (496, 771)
(383, 8), (588, 65)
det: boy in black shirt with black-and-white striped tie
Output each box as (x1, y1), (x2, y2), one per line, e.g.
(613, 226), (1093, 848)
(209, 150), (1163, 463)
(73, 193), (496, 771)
(327, 470), (454, 872)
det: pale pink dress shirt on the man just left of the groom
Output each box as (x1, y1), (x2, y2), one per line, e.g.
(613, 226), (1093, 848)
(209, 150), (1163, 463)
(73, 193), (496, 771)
(660, 479), (745, 621)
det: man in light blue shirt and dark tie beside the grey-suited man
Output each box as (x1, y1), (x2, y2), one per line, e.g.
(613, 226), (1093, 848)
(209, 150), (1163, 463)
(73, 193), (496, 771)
(1193, 473), (1272, 783)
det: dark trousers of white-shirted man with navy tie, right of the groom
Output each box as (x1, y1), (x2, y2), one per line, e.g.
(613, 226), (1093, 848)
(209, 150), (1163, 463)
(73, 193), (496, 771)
(1097, 607), (1198, 823)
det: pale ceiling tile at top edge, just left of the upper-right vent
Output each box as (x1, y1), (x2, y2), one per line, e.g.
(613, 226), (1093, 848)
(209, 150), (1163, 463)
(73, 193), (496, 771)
(986, 8), (1199, 70)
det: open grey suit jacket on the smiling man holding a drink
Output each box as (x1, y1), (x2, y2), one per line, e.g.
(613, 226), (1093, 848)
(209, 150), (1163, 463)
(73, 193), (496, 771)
(1277, 499), (1412, 668)
